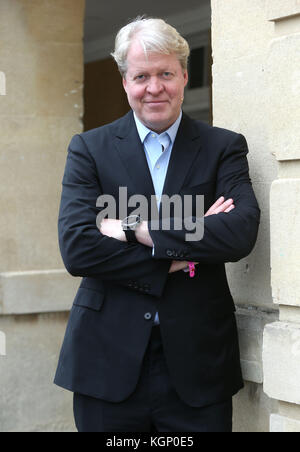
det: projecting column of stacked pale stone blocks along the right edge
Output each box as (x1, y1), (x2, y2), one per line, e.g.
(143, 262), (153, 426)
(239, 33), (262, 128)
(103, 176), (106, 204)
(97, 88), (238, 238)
(263, 0), (300, 432)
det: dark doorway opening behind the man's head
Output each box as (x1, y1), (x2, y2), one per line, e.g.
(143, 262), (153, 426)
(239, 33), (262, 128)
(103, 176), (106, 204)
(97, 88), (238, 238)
(84, 0), (212, 131)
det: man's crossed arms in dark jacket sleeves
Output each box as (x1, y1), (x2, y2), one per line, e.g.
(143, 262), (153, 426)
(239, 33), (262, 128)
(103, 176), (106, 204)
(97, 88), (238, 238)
(58, 134), (260, 297)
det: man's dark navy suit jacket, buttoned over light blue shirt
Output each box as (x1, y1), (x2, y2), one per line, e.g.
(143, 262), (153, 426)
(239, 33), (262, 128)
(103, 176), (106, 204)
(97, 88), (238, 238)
(55, 112), (260, 407)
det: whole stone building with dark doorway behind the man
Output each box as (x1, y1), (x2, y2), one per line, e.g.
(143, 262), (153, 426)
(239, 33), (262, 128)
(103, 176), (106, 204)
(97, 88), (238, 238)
(0, 0), (300, 432)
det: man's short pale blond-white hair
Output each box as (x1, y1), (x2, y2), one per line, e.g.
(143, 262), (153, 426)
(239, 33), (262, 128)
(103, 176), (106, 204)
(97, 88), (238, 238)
(111, 16), (190, 77)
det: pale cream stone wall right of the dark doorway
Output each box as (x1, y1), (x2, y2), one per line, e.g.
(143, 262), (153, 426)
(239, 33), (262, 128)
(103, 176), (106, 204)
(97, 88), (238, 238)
(212, 0), (300, 432)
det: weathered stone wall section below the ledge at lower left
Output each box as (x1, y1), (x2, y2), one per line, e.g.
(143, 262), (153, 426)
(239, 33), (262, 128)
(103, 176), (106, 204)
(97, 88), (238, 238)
(0, 313), (75, 432)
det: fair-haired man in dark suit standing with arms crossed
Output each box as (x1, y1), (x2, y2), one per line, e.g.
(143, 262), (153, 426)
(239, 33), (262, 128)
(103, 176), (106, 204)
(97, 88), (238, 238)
(55, 18), (260, 432)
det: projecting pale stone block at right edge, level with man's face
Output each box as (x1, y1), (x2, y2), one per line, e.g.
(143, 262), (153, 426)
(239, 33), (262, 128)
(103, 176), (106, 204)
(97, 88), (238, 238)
(265, 33), (300, 161)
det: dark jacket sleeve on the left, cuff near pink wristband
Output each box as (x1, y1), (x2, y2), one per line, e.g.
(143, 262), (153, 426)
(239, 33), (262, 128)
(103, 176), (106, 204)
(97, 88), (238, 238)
(58, 135), (171, 297)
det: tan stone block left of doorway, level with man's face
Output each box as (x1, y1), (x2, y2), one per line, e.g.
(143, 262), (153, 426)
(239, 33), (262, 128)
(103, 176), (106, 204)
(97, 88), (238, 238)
(0, 42), (83, 118)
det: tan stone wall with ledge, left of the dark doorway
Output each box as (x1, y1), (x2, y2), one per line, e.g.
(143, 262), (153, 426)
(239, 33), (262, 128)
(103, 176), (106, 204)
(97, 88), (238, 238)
(0, 0), (84, 431)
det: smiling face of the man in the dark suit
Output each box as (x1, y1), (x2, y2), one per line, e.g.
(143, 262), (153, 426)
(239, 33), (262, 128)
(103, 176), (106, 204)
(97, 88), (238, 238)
(123, 41), (188, 133)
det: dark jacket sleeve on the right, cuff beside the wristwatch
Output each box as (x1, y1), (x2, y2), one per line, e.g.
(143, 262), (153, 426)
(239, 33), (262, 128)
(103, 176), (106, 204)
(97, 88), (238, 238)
(149, 134), (260, 264)
